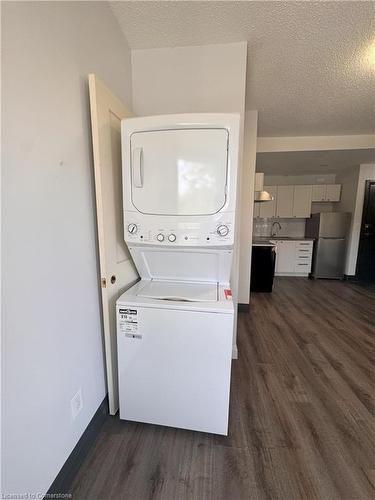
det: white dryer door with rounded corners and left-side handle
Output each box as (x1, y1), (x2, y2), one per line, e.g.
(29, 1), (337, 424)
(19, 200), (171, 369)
(131, 129), (228, 215)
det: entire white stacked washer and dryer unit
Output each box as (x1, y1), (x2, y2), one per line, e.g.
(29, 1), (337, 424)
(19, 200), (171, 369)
(117, 114), (239, 435)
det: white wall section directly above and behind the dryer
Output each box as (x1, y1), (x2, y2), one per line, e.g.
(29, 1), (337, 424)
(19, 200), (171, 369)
(132, 42), (251, 356)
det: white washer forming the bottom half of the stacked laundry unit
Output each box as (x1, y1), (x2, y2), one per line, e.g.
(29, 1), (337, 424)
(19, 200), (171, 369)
(117, 280), (233, 434)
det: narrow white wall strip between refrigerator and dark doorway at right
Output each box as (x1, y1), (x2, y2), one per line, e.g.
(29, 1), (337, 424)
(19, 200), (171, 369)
(340, 164), (375, 276)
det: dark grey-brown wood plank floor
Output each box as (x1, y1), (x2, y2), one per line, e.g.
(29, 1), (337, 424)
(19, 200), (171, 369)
(71, 278), (375, 500)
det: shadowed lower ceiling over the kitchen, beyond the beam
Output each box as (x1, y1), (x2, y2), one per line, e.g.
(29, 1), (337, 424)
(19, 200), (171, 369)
(256, 149), (375, 175)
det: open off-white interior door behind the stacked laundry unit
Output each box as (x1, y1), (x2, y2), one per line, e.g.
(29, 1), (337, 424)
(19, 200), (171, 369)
(89, 74), (138, 415)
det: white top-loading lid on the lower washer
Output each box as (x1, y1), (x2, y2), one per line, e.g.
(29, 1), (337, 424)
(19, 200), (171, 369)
(137, 280), (218, 302)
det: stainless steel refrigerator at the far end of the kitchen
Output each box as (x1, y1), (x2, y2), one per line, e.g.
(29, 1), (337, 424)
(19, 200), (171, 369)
(305, 212), (350, 279)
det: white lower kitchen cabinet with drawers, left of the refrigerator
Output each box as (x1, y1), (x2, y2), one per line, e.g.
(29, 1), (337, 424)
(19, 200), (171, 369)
(272, 240), (313, 276)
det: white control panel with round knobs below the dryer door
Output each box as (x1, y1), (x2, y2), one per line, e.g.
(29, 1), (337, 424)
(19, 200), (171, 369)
(124, 212), (234, 246)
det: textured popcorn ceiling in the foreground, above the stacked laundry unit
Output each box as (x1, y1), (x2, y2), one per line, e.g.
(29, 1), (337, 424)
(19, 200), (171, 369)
(110, 1), (375, 136)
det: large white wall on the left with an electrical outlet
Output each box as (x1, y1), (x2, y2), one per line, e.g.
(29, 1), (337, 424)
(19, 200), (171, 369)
(2, 2), (131, 494)
